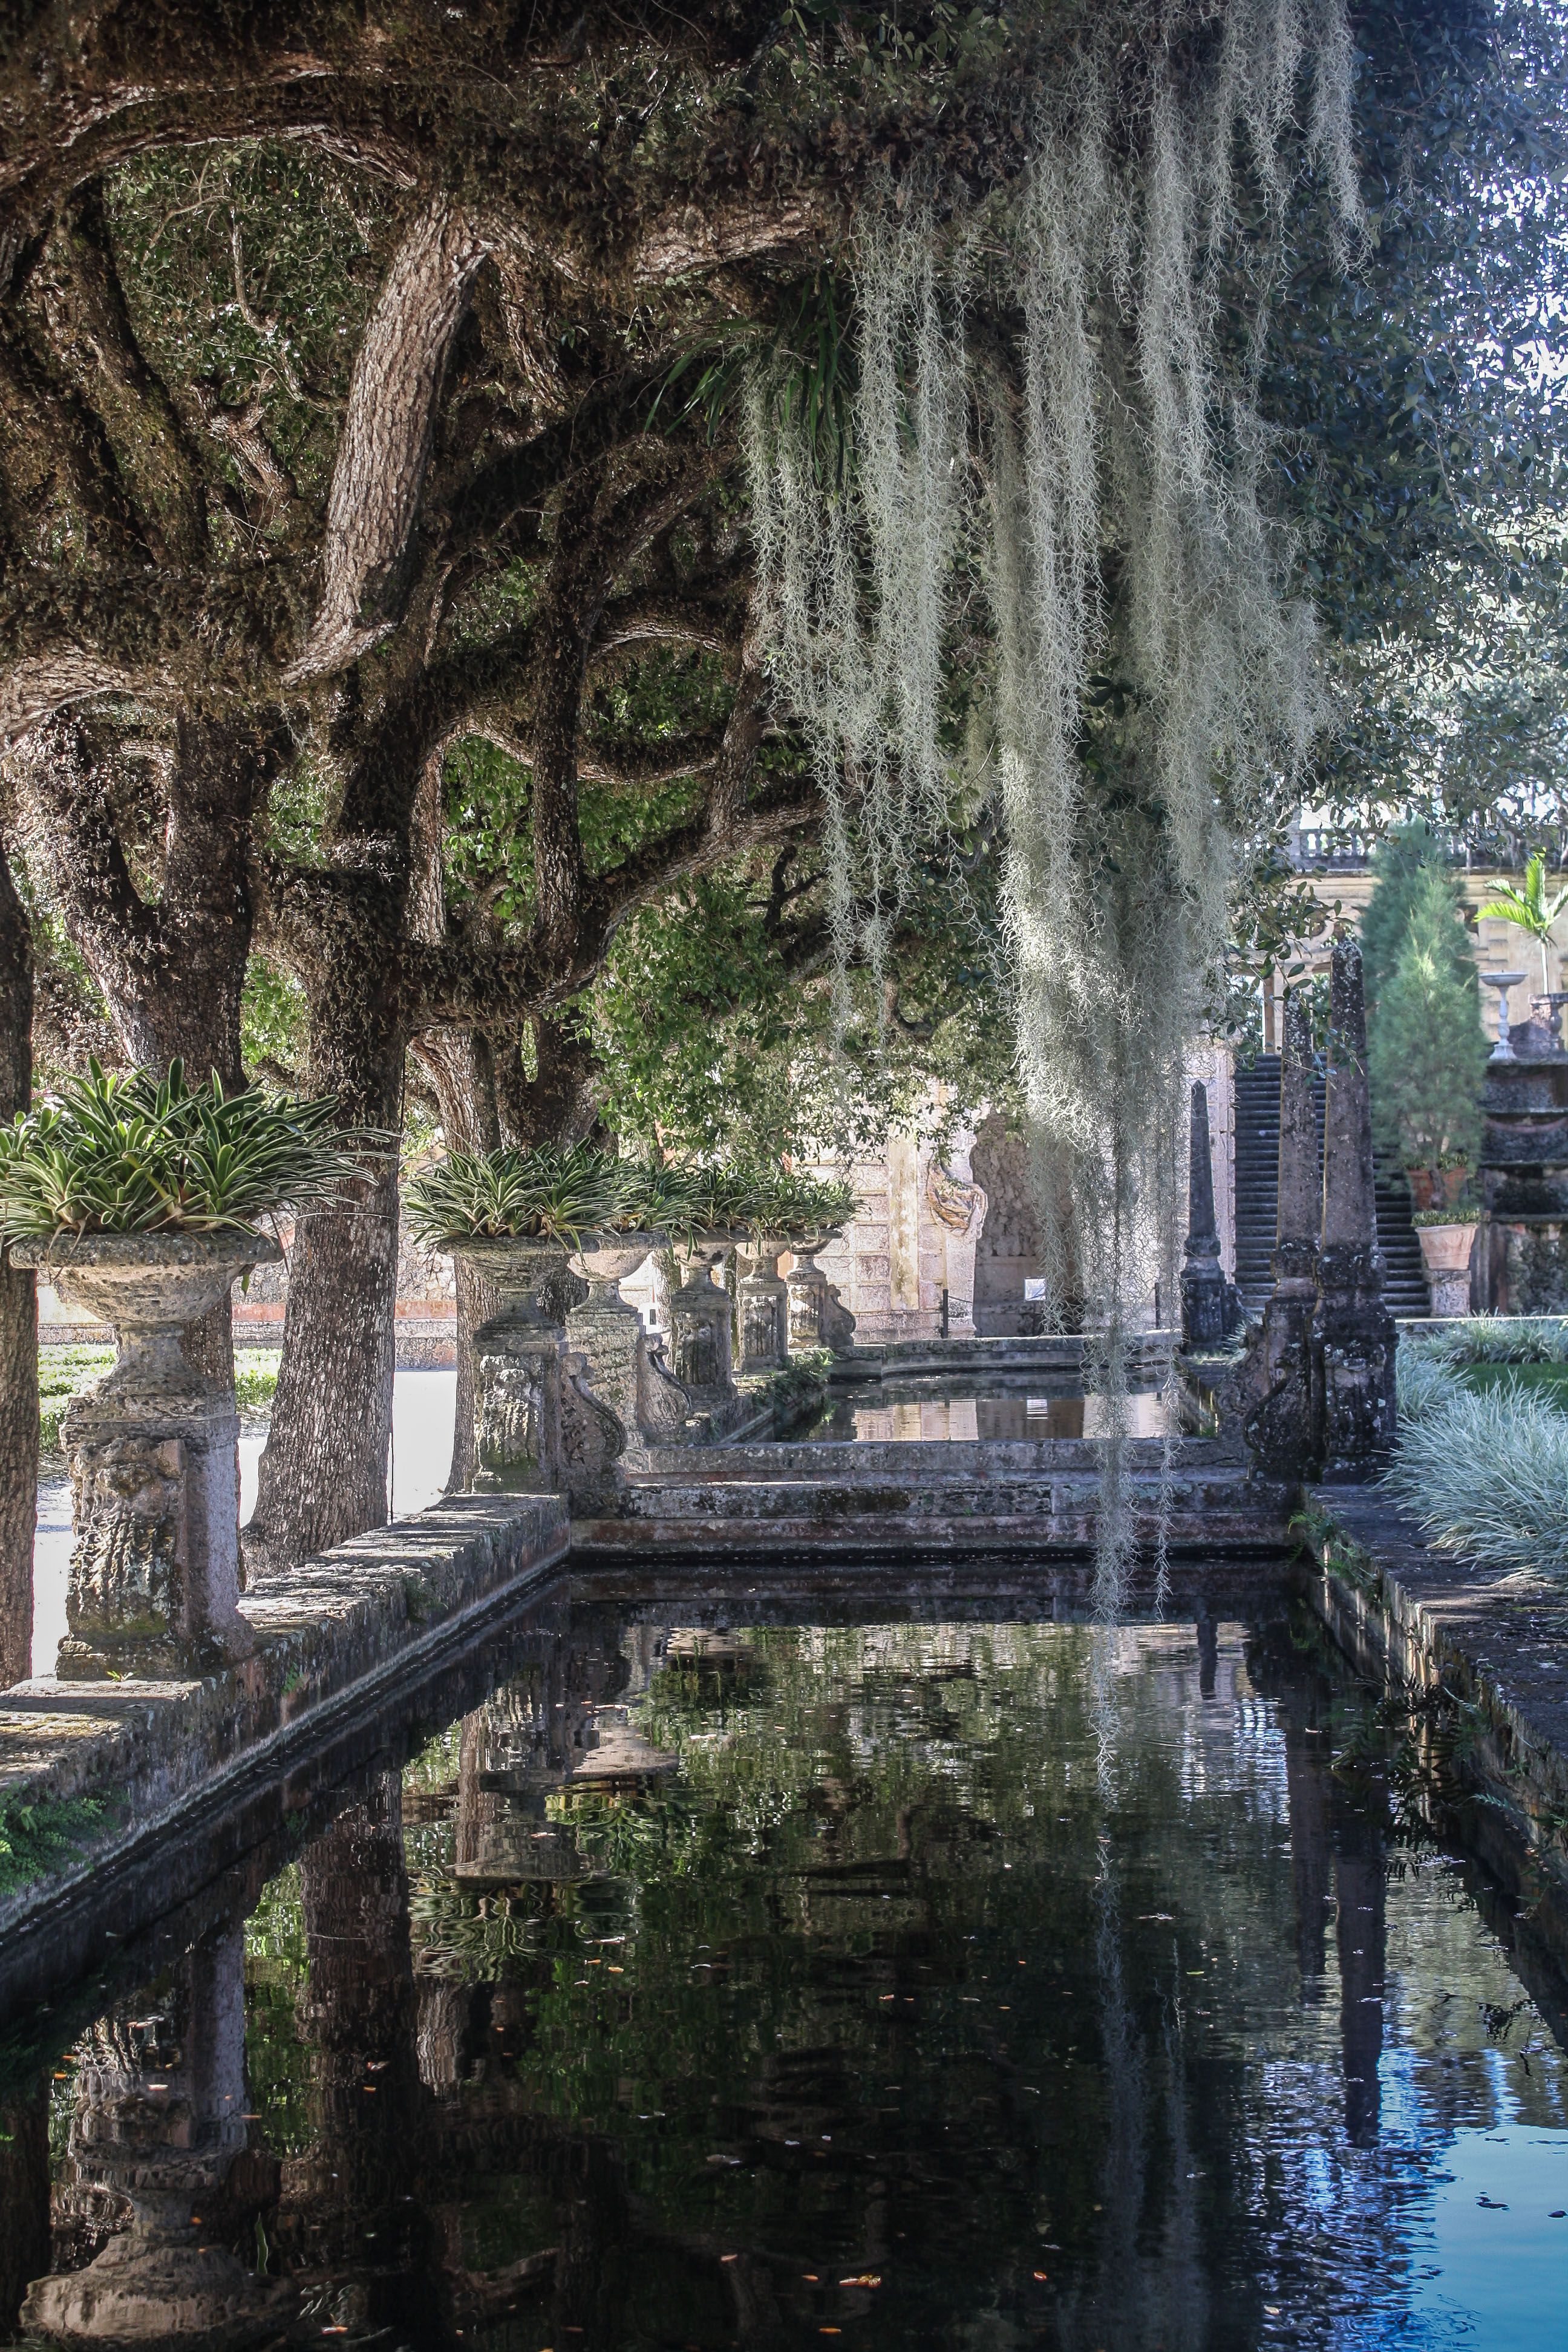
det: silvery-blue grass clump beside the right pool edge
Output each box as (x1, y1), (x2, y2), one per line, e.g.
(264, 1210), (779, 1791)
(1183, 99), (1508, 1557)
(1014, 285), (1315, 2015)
(1382, 1348), (1568, 1576)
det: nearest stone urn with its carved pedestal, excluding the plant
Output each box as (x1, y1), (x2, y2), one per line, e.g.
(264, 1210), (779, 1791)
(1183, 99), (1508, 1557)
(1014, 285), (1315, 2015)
(11, 1228), (282, 1682)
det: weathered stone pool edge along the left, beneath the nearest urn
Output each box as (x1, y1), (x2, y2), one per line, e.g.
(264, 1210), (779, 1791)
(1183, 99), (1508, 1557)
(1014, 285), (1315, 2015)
(0, 1496), (571, 1936)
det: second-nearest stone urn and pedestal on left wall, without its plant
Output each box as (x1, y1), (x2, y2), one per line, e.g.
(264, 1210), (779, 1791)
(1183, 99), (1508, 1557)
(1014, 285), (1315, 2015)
(451, 1235), (567, 1494)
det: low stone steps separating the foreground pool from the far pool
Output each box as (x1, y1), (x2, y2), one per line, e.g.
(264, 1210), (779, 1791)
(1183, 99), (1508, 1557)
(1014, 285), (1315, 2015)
(573, 1437), (1289, 1560)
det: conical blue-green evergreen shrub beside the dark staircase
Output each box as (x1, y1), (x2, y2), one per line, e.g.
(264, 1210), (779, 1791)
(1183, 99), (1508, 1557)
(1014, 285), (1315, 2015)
(1368, 872), (1491, 1178)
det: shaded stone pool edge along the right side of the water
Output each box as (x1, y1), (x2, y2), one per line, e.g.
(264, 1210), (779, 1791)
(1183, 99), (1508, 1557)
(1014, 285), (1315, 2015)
(1298, 1486), (1568, 1959)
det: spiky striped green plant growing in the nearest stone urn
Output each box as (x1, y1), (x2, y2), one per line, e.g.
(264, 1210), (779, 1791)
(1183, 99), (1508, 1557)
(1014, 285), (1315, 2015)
(0, 1060), (369, 1242)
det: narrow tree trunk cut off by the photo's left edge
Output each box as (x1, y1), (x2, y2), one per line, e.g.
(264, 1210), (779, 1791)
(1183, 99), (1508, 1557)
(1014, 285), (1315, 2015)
(0, 851), (38, 1684)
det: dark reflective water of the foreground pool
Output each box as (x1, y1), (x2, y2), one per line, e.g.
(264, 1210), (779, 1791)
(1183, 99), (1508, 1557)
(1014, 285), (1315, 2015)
(0, 1602), (1568, 2352)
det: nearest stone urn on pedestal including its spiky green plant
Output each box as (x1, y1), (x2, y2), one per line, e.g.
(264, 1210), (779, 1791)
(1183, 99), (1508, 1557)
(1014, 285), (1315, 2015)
(0, 1060), (364, 1677)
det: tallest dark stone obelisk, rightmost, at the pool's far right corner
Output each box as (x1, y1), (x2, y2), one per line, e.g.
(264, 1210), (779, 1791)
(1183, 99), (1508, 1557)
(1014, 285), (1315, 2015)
(1312, 938), (1399, 1481)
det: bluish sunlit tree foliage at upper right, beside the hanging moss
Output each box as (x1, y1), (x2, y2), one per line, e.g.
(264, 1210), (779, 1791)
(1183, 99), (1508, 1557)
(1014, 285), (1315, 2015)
(1260, 0), (1568, 861)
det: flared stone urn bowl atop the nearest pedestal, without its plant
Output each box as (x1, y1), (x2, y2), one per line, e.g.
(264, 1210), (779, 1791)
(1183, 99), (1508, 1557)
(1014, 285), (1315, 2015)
(11, 1226), (282, 1397)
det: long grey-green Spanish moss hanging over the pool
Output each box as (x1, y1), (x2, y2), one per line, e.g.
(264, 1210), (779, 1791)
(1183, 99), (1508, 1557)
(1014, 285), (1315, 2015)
(745, 0), (1356, 1616)
